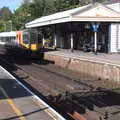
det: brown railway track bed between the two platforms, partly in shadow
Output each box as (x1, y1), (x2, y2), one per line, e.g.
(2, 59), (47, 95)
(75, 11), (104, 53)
(0, 52), (120, 120)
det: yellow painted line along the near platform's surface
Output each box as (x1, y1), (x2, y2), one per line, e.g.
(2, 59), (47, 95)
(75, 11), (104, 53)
(0, 86), (26, 120)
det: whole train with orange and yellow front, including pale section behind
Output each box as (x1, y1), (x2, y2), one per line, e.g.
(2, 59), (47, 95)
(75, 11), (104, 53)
(0, 29), (43, 56)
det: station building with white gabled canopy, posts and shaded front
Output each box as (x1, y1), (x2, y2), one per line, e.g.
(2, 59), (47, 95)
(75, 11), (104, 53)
(26, 3), (120, 53)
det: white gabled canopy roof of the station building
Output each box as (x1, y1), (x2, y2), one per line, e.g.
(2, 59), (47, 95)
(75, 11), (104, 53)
(25, 3), (120, 28)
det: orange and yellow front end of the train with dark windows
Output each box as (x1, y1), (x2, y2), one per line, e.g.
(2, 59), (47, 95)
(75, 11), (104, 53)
(17, 30), (42, 56)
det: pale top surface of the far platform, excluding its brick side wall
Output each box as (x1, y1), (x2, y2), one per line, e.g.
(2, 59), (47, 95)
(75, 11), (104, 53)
(46, 49), (120, 66)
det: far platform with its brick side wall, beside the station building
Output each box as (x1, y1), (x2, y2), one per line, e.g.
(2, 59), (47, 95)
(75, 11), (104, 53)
(44, 50), (120, 82)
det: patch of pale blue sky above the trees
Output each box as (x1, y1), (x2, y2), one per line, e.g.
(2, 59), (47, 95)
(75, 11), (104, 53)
(0, 0), (23, 11)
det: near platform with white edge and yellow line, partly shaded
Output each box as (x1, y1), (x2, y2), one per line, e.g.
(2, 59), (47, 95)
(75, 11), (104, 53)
(0, 66), (65, 120)
